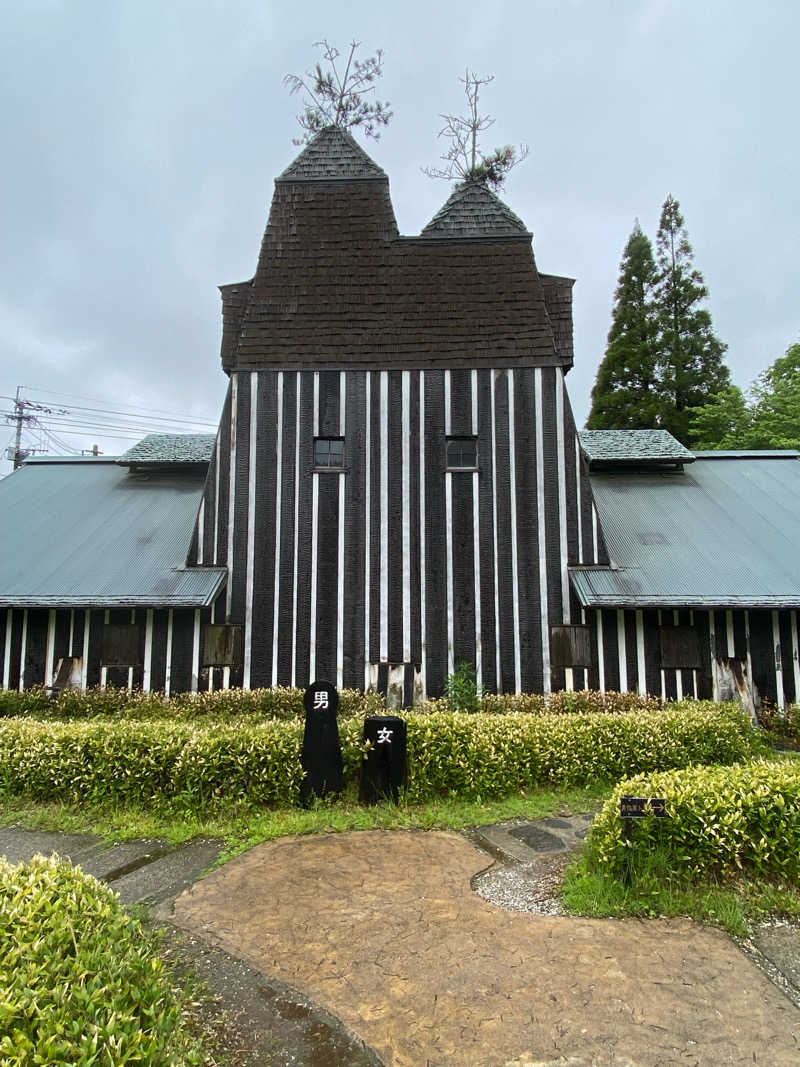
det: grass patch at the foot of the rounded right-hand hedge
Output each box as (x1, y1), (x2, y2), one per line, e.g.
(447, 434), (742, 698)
(562, 850), (800, 937)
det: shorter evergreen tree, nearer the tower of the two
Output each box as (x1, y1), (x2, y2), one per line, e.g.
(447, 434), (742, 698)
(587, 221), (660, 430)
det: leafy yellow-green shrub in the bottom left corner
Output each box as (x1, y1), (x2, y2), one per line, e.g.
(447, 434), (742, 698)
(0, 856), (203, 1067)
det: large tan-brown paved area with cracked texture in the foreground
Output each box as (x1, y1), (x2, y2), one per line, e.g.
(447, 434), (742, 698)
(172, 830), (800, 1067)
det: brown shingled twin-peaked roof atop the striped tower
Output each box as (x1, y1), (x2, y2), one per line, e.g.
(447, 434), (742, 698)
(221, 126), (572, 372)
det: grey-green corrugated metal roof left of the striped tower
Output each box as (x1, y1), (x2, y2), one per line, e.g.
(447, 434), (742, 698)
(0, 458), (226, 607)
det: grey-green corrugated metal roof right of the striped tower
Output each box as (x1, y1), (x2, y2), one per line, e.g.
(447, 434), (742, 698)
(570, 453), (800, 607)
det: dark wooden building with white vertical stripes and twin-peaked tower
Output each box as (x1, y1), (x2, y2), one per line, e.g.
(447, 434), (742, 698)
(0, 128), (800, 703)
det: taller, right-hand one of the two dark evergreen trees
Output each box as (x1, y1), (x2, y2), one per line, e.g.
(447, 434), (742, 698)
(656, 195), (730, 445)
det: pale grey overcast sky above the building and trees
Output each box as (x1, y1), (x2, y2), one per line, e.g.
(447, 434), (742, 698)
(0, 0), (800, 473)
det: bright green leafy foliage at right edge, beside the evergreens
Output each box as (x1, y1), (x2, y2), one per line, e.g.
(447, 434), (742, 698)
(690, 344), (800, 449)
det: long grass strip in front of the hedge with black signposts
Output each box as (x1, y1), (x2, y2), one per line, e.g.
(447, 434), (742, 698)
(0, 783), (611, 862)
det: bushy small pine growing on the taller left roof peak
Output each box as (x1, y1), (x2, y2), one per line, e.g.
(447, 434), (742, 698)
(284, 38), (391, 144)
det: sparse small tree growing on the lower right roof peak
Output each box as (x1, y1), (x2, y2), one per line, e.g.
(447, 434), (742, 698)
(422, 67), (529, 189)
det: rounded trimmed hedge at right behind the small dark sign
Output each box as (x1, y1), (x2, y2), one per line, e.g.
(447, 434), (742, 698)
(587, 760), (800, 880)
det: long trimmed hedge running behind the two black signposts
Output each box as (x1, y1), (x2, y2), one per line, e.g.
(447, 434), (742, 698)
(0, 703), (763, 810)
